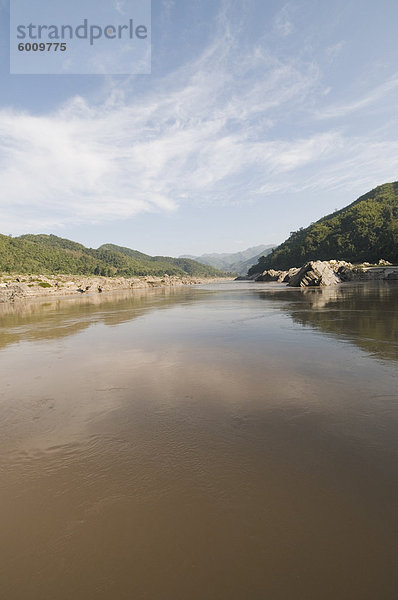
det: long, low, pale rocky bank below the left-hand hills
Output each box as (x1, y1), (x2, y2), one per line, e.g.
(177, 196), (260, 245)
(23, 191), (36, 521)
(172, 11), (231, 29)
(0, 274), (224, 303)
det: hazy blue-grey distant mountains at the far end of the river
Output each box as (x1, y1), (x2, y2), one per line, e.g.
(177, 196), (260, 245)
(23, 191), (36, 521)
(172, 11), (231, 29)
(180, 244), (275, 275)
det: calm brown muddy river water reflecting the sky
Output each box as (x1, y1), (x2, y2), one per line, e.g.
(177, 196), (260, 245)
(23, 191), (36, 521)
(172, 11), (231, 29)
(0, 282), (398, 600)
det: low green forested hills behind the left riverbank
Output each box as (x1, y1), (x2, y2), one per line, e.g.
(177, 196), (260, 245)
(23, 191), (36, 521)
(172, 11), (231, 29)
(0, 234), (225, 277)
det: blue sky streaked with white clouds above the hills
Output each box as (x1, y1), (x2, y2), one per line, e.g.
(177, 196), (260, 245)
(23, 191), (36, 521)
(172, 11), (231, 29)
(0, 0), (398, 256)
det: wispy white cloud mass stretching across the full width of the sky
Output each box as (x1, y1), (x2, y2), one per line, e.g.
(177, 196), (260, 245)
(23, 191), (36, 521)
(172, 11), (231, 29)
(0, 2), (398, 232)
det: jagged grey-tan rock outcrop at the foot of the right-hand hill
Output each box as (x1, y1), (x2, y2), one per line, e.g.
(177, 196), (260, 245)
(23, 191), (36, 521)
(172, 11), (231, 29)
(237, 260), (398, 287)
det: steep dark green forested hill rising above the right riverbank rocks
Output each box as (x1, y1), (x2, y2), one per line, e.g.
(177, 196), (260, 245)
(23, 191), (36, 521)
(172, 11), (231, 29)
(249, 182), (398, 275)
